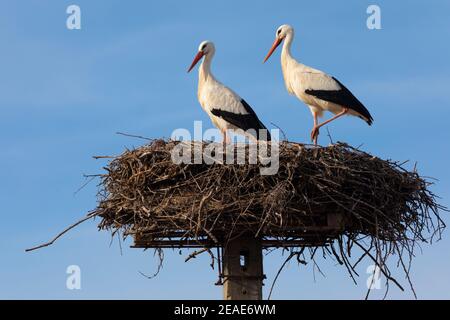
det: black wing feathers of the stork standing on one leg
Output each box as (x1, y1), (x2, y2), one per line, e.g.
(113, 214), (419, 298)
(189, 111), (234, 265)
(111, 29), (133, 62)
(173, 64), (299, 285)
(305, 77), (373, 126)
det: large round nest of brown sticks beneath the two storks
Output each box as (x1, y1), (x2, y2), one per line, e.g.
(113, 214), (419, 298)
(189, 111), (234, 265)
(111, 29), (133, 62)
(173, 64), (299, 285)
(95, 140), (445, 296)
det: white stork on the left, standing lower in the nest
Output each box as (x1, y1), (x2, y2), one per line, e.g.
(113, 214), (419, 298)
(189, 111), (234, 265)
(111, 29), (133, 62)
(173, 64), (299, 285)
(188, 41), (270, 143)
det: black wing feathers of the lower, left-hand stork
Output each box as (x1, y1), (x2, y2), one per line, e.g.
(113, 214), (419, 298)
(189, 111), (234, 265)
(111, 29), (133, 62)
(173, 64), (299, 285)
(211, 99), (270, 140)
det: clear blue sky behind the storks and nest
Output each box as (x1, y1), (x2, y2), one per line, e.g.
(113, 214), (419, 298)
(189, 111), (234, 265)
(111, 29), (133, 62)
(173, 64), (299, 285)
(0, 0), (450, 299)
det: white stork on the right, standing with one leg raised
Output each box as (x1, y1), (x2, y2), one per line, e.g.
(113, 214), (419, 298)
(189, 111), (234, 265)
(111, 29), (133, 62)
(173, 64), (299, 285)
(264, 24), (373, 144)
